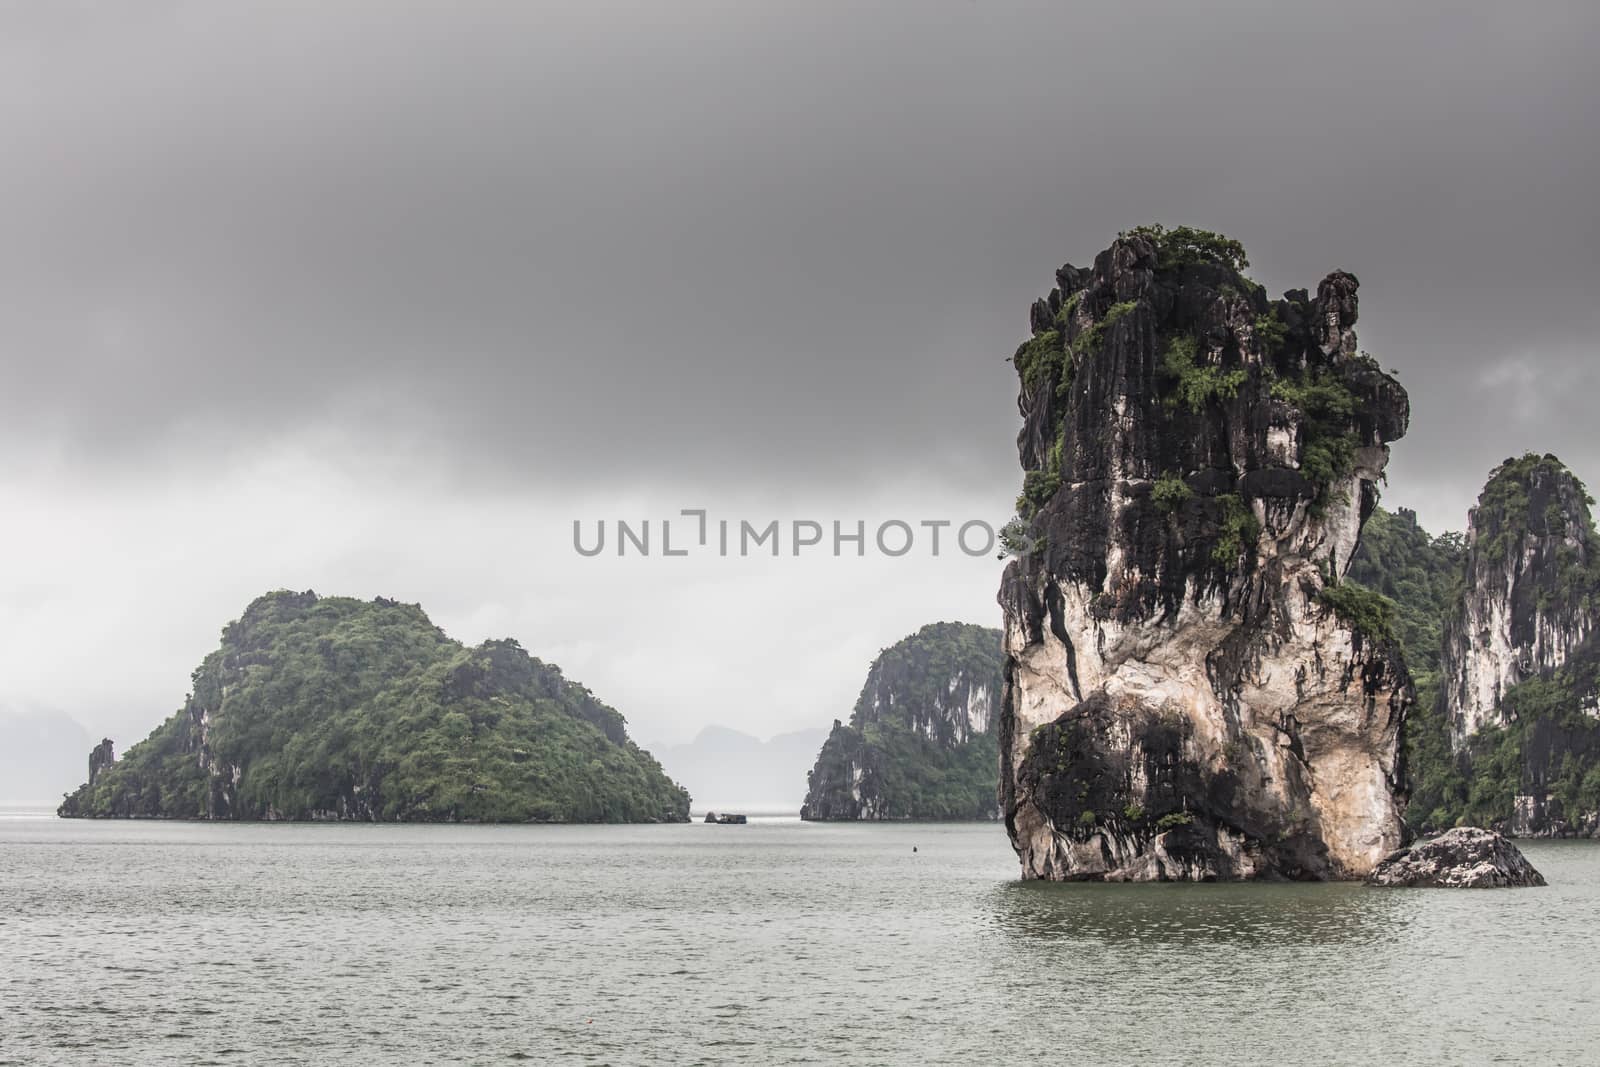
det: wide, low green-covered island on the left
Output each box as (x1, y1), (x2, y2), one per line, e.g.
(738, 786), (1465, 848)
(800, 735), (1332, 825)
(59, 592), (690, 822)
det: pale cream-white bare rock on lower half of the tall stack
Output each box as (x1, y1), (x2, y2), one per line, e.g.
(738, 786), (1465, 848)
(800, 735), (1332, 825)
(1005, 463), (1403, 880)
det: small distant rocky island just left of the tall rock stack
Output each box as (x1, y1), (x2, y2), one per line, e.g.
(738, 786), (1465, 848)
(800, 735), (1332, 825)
(800, 622), (1000, 821)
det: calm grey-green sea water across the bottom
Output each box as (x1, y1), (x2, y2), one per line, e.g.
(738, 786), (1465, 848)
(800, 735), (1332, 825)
(0, 816), (1600, 1064)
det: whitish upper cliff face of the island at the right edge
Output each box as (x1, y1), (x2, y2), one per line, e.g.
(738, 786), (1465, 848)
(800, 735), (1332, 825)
(1442, 456), (1600, 750)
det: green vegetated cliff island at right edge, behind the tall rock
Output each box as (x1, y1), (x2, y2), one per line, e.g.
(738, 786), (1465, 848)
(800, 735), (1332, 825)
(1350, 454), (1600, 837)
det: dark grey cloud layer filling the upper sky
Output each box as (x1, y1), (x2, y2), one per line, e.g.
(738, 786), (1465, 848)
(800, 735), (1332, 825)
(0, 3), (1600, 523)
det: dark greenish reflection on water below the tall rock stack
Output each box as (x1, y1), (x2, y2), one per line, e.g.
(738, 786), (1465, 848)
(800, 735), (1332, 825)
(987, 881), (1416, 947)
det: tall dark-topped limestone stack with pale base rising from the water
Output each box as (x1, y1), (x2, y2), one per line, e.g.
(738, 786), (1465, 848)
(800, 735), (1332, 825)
(997, 230), (1411, 880)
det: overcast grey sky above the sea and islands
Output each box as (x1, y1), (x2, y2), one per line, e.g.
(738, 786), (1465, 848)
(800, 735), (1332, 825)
(0, 0), (1600, 767)
